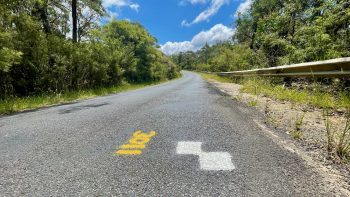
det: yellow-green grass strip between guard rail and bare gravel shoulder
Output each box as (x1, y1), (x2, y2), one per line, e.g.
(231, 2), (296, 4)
(201, 74), (350, 109)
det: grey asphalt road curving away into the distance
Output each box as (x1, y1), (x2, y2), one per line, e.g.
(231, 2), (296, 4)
(0, 72), (332, 197)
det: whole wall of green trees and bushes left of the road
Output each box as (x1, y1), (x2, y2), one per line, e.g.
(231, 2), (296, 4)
(0, 0), (178, 99)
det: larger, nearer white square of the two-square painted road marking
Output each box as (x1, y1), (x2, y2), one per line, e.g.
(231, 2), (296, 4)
(199, 152), (235, 171)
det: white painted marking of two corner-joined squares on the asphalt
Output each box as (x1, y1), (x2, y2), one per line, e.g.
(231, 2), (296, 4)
(176, 142), (235, 171)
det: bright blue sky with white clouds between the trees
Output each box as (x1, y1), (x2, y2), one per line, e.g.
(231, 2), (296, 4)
(103, 0), (252, 55)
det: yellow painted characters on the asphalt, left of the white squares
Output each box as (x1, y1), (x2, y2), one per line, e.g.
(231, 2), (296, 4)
(115, 130), (157, 155)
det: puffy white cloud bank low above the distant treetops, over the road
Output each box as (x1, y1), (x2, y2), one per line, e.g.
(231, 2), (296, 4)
(161, 24), (234, 55)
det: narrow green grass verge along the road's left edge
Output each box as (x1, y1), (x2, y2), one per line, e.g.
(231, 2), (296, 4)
(0, 82), (167, 114)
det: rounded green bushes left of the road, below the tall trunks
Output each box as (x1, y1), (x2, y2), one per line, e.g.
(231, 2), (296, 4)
(0, 17), (178, 99)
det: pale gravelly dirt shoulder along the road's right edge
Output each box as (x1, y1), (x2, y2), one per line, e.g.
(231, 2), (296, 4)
(208, 80), (350, 194)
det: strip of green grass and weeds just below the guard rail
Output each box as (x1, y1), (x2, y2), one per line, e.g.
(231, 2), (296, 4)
(201, 73), (350, 111)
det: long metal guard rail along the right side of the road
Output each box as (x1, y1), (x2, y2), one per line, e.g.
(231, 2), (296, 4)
(214, 57), (350, 77)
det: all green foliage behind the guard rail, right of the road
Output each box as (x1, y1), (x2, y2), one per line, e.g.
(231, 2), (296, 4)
(173, 0), (350, 71)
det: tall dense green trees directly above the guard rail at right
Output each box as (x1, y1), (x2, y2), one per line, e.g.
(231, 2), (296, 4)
(235, 0), (350, 66)
